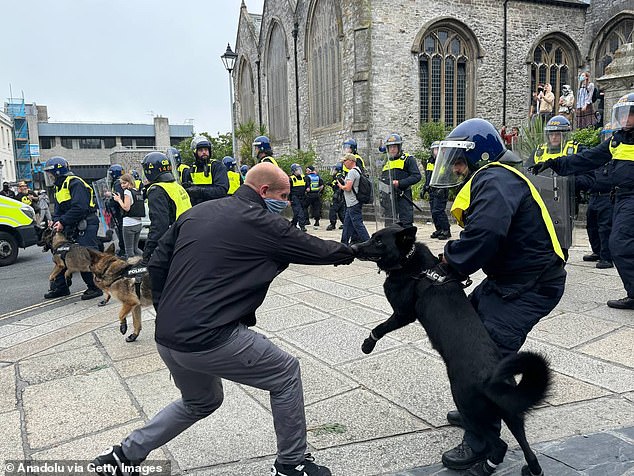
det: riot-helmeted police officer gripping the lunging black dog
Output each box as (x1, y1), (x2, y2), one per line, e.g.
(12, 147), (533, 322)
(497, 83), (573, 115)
(430, 119), (566, 474)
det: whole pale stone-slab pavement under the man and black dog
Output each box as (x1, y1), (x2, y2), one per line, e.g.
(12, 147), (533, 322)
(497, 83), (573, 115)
(0, 222), (634, 476)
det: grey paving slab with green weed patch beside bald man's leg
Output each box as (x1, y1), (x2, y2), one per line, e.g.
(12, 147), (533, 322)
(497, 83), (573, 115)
(306, 389), (429, 449)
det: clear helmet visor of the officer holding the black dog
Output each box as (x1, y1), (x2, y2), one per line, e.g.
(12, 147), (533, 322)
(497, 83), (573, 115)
(430, 140), (475, 188)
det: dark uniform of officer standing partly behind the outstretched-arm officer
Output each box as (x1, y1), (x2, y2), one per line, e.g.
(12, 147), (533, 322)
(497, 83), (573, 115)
(575, 164), (614, 263)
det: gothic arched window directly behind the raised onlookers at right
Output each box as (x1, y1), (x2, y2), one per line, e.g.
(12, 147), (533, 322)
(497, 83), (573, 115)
(531, 36), (577, 104)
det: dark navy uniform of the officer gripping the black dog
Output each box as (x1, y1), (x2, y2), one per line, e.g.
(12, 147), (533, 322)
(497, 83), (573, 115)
(444, 166), (566, 453)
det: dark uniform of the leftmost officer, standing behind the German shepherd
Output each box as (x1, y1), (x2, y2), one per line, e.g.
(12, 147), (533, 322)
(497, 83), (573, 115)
(51, 174), (102, 296)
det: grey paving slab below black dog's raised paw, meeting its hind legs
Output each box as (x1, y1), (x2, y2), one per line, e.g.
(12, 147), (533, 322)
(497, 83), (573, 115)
(339, 347), (454, 427)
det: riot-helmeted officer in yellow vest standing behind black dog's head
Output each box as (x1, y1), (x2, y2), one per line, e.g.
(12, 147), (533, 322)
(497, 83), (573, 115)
(379, 133), (422, 227)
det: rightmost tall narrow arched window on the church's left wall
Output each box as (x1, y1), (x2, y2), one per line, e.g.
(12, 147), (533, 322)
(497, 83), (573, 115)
(308, 0), (342, 128)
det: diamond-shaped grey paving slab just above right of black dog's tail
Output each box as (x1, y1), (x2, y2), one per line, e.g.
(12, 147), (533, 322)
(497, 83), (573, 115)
(530, 312), (619, 349)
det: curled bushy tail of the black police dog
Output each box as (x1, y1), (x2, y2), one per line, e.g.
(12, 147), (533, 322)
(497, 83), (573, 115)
(487, 352), (552, 414)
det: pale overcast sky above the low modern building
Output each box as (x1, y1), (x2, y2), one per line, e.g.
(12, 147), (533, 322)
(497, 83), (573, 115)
(0, 0), (264, 135)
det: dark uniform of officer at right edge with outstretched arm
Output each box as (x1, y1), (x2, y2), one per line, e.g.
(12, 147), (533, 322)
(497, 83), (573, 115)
(548, 130), (634, 299)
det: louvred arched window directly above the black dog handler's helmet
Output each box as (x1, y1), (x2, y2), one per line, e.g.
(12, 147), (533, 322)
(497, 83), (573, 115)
(418, 25), (475, 126)
